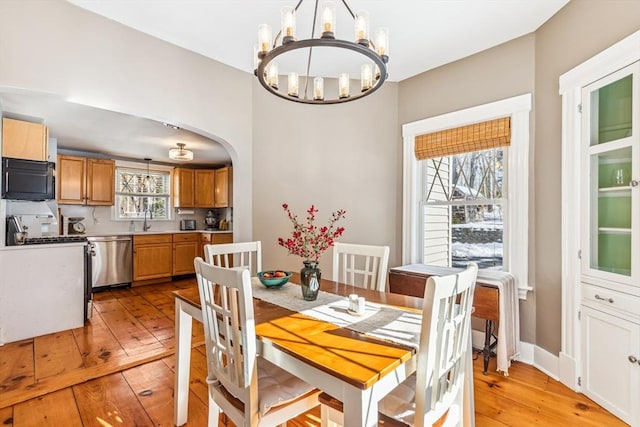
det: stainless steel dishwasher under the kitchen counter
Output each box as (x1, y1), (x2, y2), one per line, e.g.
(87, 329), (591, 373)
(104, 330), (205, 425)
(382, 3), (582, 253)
(87, 236), (133, 290)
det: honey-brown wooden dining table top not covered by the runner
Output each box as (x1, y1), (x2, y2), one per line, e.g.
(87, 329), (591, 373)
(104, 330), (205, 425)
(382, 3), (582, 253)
(173, 273), (422, 389)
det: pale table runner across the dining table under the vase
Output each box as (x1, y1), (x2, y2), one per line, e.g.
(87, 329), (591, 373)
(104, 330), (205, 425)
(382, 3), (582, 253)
(251, 277), (422, 350)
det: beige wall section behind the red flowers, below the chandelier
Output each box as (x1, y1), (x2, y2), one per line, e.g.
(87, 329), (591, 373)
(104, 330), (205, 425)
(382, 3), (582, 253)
(253, 78), (401, 278)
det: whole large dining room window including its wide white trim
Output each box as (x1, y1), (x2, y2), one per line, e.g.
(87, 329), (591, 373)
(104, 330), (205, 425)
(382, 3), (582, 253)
(402, 94), (531, 299)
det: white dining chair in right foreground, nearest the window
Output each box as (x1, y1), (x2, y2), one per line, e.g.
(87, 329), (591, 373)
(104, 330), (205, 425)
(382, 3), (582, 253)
(319, 263), (478, 427)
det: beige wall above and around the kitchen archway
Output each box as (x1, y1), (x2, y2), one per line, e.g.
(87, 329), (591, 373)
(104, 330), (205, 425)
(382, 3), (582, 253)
(0, 0), (253, 239)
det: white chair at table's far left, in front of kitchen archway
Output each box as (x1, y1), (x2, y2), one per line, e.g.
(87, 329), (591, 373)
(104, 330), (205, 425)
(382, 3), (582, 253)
(204, 241), (262, 275)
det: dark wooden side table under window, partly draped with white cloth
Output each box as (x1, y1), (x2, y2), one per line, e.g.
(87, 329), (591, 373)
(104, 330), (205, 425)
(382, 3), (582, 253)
(389, 266), (500, 375)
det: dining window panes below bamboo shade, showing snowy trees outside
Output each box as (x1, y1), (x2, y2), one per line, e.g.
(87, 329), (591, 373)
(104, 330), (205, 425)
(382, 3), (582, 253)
(420, 147), (507, 270)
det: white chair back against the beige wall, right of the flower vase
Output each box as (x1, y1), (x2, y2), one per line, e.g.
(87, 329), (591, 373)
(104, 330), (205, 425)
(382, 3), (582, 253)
(333, 242), (389, 292)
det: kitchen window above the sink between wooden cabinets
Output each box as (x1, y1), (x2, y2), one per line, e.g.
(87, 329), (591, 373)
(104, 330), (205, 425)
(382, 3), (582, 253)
(115, 167), (171, 219)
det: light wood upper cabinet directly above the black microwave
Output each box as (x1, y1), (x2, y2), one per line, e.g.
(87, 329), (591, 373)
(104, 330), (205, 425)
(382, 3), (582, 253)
(2, 117), (49, 161)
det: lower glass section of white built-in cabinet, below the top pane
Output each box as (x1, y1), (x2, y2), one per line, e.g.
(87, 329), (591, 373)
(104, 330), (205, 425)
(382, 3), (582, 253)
(590, 147), (632, 276)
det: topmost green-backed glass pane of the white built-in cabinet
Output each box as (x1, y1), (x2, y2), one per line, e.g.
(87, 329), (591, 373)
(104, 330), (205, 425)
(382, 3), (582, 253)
(590, 75), (633, 145)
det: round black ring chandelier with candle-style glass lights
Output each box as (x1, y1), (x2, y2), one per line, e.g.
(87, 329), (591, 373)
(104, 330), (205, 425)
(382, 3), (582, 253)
(254, 0), (389, 104)
